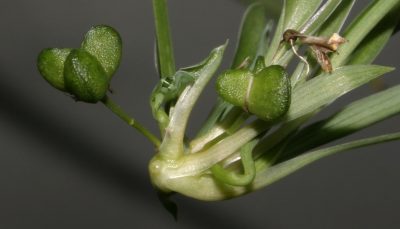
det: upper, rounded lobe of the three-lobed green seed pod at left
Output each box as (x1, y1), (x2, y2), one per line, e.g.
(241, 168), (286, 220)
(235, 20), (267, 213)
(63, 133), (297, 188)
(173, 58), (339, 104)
(81, 25), (122, 78)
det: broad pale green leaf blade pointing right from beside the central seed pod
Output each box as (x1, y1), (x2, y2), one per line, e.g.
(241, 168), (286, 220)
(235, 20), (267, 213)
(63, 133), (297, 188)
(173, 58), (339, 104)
(287, 65), (393, 121)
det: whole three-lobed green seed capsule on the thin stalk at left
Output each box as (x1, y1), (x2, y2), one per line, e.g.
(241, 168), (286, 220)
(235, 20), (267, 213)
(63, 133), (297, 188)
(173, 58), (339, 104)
(37, 25), (122, 103)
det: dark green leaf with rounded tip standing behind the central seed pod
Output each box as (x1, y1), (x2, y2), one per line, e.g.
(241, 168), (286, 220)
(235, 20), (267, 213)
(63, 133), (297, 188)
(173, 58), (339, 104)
(231, 3), (268, 69)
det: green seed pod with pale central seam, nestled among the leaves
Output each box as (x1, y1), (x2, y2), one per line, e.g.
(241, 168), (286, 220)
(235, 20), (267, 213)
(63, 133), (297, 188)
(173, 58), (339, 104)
(217, 65), (291, 122)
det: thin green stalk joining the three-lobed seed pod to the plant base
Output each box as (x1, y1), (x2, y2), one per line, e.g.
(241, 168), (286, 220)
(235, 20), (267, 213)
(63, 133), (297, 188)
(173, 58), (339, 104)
(101, 96), (161, 148)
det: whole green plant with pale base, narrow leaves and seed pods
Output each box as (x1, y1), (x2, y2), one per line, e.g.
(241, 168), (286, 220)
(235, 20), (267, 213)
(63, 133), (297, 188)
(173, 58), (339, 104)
(38, 0), (400, 215)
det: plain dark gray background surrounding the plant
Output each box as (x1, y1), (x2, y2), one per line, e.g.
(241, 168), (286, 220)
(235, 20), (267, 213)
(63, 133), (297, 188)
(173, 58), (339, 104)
(0, 0), (400, 229)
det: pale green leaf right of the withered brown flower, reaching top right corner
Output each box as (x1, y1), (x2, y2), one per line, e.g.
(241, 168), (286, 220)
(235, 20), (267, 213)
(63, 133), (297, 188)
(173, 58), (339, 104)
(332, 0), (400, 68)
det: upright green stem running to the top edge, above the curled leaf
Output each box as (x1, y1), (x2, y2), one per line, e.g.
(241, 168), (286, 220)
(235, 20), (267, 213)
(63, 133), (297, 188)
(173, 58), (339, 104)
(153, 0), (175, 78)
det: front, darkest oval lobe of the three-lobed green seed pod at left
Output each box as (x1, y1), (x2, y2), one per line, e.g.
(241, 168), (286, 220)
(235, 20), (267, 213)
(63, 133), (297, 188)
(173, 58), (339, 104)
(64, 49), (110, 103)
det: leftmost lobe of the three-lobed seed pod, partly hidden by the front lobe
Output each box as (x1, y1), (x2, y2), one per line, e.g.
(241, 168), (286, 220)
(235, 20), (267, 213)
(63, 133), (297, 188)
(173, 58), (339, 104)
(37, 48), (71, 91)
